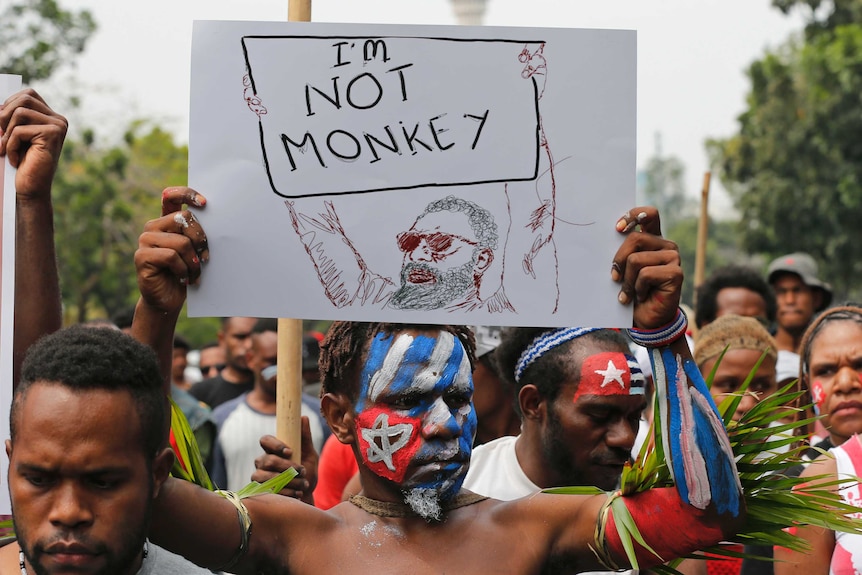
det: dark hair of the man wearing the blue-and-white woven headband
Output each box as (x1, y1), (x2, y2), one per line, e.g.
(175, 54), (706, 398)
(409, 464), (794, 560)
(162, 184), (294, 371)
(494, 327), (629, 412)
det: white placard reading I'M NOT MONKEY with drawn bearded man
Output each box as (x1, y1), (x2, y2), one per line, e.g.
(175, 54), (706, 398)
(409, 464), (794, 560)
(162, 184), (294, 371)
(189, 22), (636, 327)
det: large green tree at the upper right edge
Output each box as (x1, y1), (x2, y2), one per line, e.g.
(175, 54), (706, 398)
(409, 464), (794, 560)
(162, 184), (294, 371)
(709, 0), (862, 300)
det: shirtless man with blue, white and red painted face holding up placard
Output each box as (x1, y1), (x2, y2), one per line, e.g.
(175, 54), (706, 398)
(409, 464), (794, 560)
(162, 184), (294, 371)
(134, 188), (745, 574)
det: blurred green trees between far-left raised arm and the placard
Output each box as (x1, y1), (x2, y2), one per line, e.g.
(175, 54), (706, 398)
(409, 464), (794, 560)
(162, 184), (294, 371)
(53, 123), (188, 322)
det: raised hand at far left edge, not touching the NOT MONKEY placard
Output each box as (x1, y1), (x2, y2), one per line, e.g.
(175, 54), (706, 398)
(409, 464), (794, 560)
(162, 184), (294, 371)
(0, 89), (69, 206)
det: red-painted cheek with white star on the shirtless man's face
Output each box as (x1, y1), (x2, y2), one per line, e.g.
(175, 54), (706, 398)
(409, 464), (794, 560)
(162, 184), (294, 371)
(356, 406), (422, 483)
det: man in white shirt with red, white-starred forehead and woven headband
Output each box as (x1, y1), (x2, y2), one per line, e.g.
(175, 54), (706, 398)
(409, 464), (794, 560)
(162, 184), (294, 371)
(465, 328), (646, 500)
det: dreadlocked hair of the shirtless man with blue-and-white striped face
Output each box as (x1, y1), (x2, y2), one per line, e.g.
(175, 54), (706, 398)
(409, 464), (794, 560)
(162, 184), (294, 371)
(320, 321), (476, 400)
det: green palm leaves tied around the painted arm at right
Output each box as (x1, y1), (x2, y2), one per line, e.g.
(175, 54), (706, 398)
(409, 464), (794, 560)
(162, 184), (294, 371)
(545, 358), (862, 575)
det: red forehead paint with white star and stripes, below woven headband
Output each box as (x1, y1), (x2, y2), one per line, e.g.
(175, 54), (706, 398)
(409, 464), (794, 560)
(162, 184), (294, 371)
(574, 351), (644, 401)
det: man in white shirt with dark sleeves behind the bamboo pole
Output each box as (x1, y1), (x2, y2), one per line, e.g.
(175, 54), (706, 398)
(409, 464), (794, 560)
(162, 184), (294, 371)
(212, 319), (325, 501)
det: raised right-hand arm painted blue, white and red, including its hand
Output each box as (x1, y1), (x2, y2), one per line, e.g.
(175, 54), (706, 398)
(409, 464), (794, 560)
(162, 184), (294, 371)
(600, 208), (745, 567)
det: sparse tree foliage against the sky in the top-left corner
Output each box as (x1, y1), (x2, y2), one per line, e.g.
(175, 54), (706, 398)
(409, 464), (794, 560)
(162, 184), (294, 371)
(0, 0), (96, 84)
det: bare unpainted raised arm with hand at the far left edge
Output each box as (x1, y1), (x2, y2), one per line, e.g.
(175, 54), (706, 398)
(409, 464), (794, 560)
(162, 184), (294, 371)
(0, 90), (68, 385)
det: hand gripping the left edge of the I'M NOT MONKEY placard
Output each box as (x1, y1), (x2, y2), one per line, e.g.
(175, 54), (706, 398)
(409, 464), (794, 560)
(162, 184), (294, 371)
(135, 187), (209, 312)
